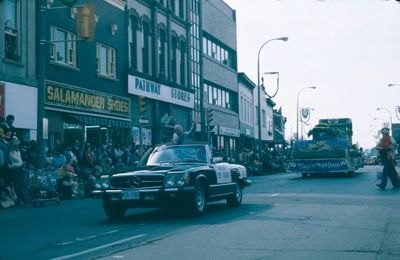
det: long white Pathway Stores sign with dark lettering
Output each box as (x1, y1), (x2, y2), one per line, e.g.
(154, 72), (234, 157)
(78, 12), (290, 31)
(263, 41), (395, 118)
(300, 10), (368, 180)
(128, 75), (194, 108)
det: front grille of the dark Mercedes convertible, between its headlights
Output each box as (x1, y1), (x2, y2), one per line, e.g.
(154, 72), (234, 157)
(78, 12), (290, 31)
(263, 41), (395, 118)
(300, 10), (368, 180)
(110, 175), (164, 189)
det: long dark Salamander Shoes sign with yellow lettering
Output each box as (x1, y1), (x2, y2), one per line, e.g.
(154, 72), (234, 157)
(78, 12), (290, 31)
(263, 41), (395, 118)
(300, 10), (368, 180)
(46, 82), (131, 117)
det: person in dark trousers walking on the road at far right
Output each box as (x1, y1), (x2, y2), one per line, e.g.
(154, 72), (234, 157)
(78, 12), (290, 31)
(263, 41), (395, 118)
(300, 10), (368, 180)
(376, 127), (400, 190)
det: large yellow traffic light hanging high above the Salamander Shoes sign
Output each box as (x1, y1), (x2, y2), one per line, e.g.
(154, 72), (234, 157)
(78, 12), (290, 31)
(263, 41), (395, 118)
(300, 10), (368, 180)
(76, 3), (96, 41)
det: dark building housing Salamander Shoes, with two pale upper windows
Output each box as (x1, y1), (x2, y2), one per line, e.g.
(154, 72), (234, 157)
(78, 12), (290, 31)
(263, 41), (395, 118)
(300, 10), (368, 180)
(42, 0), (132, 150)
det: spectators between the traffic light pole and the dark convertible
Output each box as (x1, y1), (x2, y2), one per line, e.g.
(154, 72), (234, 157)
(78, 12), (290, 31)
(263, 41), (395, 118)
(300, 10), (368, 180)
(45, 140), (143, 199)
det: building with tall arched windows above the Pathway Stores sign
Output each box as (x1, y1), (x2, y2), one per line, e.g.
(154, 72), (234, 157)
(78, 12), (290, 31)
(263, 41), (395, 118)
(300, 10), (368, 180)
(127, 0), (195, 145)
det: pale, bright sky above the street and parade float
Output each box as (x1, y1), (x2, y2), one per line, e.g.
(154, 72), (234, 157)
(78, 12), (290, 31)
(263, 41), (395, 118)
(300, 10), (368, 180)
(222, 0), (400, 149)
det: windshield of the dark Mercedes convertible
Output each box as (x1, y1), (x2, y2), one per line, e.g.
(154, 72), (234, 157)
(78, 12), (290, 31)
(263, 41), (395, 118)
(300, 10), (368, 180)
(147, 146), (207, 165)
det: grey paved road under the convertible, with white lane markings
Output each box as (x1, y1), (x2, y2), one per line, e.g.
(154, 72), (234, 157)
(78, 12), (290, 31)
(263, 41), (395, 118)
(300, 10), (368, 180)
(0, 167), (400, 260)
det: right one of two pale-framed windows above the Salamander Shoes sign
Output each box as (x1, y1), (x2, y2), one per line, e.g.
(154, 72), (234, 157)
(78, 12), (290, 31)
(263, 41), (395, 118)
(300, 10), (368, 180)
(97, 43), (116, 78)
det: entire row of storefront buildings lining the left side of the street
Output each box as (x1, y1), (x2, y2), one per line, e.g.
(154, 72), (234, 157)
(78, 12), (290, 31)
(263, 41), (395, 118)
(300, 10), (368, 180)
(0, 0), (284, 158)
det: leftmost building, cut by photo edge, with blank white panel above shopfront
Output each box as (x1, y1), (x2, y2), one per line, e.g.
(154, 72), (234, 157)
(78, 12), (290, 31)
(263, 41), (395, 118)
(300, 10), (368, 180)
(0, 0), (37, 141)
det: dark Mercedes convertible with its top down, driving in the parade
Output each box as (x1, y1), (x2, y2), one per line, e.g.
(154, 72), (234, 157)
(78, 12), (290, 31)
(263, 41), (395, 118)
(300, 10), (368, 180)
(92, 144), (251, 219)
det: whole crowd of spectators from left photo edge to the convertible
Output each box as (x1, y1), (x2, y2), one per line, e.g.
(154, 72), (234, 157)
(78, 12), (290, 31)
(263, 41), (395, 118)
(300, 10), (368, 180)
(0, 112), (143, 208)
